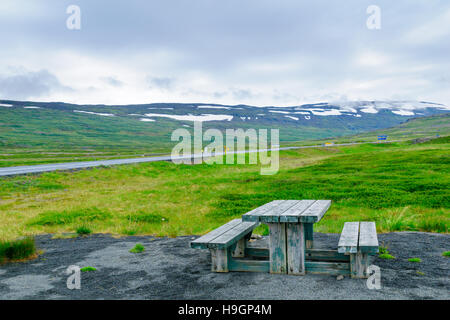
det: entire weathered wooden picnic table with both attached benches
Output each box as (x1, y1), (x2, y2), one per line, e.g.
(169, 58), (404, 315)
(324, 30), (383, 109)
(190, 200), (378, 278)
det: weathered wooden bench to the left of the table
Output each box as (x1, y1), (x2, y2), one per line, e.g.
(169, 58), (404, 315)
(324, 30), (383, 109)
(190, 219), (259, 272)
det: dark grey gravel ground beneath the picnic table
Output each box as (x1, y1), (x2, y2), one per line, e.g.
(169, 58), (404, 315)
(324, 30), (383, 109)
(0, 232), (450, 300)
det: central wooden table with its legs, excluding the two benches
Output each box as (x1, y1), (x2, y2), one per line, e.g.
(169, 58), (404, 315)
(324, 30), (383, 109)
(242, 200), (331, 275)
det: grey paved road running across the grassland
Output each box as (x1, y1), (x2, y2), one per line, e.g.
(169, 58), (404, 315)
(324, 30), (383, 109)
(0, 141), (382, 176)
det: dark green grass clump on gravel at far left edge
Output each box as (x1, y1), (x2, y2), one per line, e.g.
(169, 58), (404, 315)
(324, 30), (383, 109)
(0, 237), (36, 264)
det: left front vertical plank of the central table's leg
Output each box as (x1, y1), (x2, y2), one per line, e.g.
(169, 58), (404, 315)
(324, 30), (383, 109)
(269, 223), (287, 273)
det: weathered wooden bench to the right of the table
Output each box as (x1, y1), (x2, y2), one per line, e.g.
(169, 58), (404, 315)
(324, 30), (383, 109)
(338, 222), (378, 278)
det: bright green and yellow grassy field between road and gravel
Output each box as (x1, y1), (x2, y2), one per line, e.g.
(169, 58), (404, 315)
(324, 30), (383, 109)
(0, 137), (450, 240)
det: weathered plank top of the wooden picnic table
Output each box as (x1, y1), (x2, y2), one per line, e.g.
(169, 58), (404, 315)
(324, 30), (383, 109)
(242, 200), (331, 223)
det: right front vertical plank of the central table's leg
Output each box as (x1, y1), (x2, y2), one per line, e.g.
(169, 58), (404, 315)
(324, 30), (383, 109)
(286, 223), (305, 275)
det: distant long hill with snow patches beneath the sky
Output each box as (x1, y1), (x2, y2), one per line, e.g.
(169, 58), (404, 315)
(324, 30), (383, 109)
(0, 100), (450, 152)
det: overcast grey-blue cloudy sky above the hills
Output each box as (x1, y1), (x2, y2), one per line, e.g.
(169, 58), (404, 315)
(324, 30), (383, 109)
(0, 0), (450, 106)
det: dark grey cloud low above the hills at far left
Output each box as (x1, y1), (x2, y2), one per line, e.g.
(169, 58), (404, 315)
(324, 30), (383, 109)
(0, 70), (72, 99)
